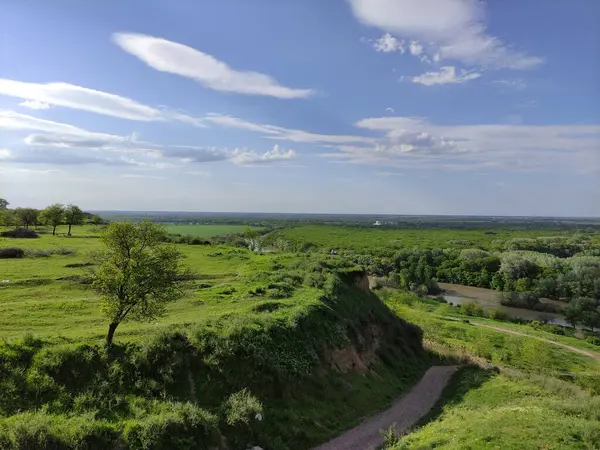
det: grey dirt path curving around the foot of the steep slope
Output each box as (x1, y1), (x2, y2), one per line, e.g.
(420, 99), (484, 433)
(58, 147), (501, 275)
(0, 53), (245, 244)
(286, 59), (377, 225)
(314, 366), (458, 450)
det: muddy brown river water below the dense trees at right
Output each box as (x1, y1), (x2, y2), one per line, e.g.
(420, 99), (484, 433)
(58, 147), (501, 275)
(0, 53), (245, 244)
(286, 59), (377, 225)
(439, 283), (569, 327)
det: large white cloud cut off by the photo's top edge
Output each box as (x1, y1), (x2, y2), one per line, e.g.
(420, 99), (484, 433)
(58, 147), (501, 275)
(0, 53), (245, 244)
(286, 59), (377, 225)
(350, 0), (543, 69)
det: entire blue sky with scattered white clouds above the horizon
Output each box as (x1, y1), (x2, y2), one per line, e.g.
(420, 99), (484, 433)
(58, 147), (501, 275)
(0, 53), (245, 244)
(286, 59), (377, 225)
(0, 0), (600, 216)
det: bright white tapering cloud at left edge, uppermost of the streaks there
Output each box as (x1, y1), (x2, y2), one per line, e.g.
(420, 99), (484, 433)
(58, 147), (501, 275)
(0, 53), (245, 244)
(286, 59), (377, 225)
(0, 79), (203, 127)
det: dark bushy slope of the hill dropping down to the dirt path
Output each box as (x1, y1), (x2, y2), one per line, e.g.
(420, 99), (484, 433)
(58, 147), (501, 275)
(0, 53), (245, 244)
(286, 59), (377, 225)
(0, 258), (430, 449)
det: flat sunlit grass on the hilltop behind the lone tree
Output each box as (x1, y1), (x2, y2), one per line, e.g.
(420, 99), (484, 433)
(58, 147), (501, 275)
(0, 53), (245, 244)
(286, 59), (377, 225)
(0, 227), (276, 340)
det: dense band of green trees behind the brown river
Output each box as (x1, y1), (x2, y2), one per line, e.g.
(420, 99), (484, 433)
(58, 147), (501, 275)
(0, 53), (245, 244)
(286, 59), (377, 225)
(273, 233), (600, 328)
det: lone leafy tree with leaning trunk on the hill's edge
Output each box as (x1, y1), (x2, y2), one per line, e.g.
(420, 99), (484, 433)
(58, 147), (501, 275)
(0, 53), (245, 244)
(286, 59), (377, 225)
(92, 221), (186, 346)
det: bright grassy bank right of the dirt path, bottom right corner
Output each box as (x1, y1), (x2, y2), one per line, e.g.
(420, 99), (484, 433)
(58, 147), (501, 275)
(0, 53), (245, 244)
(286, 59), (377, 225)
(392, 368), (600, 450)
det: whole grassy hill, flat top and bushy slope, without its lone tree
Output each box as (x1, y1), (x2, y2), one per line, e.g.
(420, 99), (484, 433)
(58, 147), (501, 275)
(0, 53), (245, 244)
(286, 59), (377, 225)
(0, 229), (434, 449)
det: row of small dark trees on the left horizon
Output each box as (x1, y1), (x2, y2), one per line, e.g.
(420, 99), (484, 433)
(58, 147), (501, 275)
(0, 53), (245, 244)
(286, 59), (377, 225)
(0, 199), (105, 236)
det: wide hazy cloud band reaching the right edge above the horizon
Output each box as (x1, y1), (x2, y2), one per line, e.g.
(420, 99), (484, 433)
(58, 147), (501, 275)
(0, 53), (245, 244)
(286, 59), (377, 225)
(350, 117), (600, 171)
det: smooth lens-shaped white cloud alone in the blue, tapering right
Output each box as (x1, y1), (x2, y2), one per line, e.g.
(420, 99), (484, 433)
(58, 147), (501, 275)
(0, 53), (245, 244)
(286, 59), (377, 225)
(113, 33), (314, 99)
